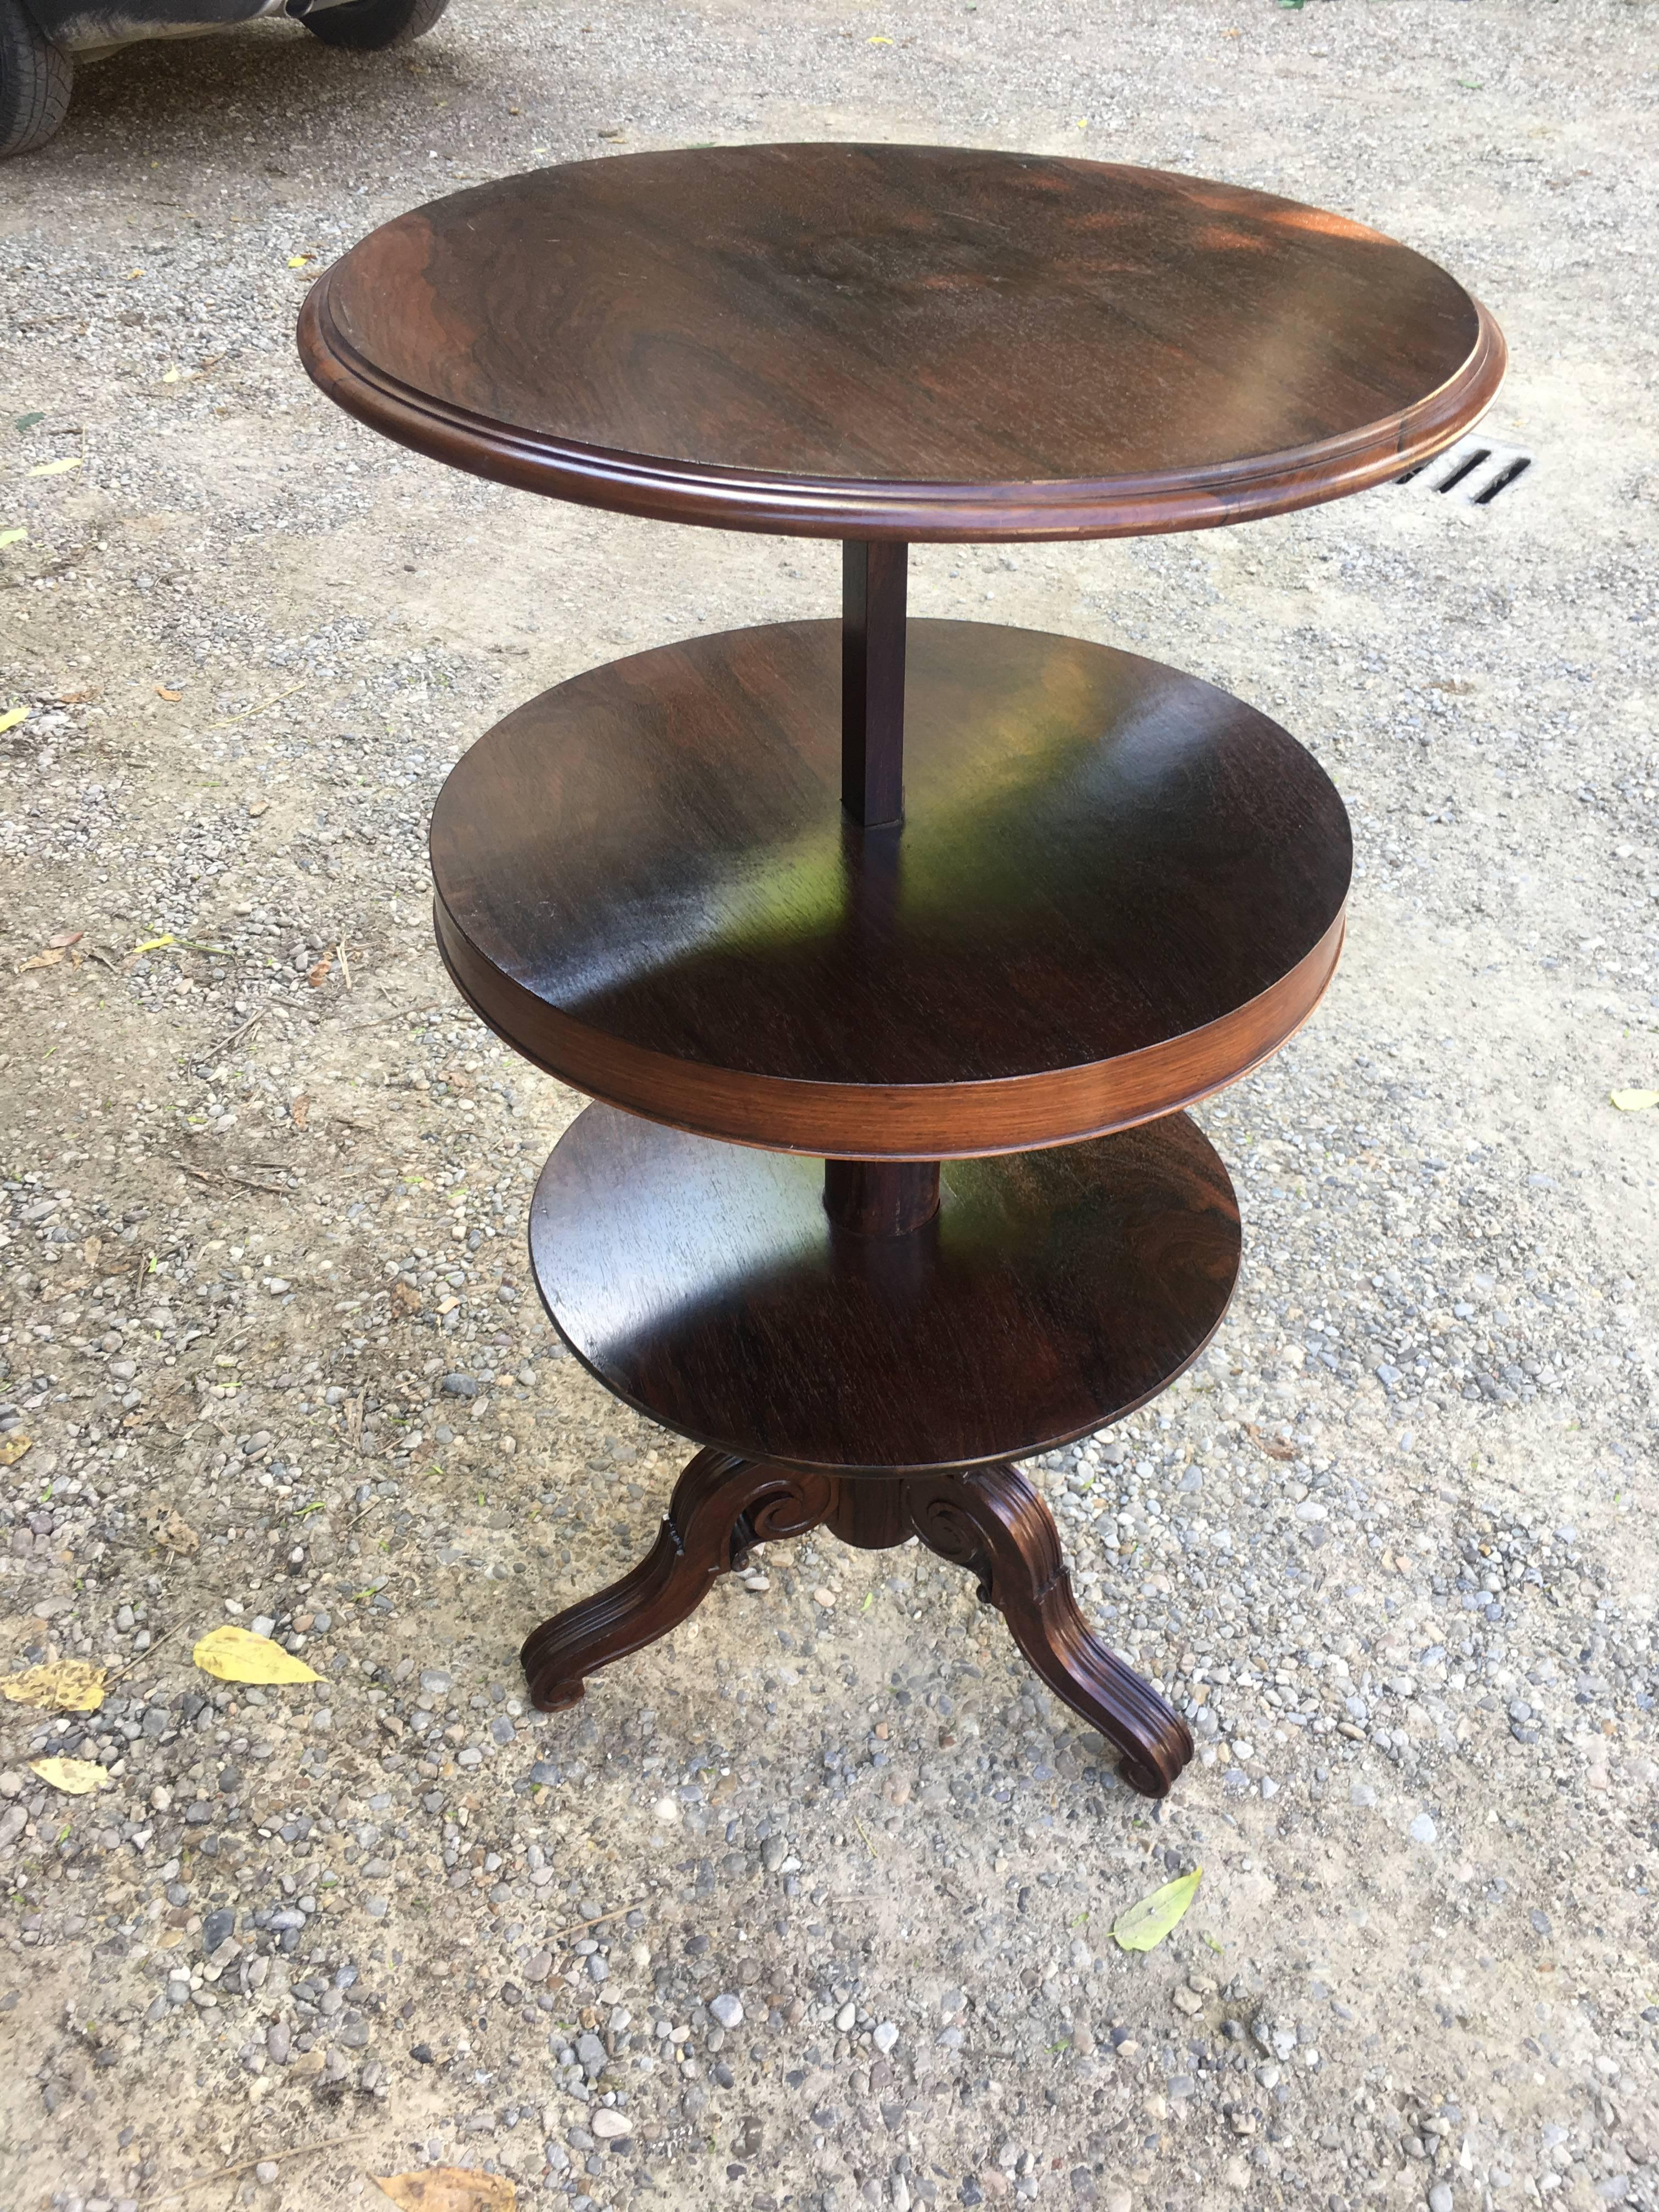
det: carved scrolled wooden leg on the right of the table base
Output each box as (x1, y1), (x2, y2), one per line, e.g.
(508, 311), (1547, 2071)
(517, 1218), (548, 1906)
(905, 1466), (1192, 1798)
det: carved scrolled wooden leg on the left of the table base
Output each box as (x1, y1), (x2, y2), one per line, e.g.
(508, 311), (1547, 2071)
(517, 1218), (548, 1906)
(520, 1451), (830, 1712)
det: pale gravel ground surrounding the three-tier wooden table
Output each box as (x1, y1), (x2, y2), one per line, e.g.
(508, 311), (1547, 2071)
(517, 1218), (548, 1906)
(0, 0), (1659, 2212)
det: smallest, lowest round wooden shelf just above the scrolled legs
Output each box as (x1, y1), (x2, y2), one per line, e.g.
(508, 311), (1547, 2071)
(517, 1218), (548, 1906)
(531, 1106), (1239, 1475)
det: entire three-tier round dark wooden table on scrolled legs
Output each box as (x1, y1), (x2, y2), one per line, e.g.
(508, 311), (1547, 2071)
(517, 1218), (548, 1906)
(301, 146), (1504, 1796)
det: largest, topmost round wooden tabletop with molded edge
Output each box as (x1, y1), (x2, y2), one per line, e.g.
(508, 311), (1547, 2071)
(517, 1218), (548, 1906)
(301, 146), (1504, 540)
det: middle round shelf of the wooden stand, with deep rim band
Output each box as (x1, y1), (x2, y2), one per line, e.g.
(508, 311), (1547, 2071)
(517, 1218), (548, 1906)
(431, 622), (1352, 1159)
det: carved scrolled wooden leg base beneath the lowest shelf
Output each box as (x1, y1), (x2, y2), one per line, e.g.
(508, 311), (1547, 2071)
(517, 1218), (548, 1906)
(520, 1451), (1192, 1798)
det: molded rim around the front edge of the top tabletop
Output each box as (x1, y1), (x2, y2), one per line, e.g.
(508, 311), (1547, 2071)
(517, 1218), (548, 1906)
(296, 263), (1509, 544)
